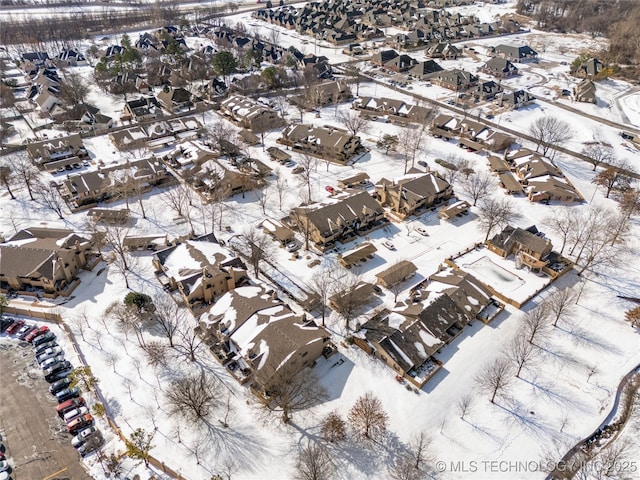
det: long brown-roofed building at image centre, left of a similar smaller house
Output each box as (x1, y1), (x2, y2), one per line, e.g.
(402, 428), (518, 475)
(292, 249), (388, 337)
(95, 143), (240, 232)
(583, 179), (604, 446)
(289, 190), (386, 250)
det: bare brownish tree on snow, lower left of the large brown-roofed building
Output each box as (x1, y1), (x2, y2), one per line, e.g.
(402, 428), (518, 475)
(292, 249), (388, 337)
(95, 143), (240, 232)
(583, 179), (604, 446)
(164, 370), (220, 422)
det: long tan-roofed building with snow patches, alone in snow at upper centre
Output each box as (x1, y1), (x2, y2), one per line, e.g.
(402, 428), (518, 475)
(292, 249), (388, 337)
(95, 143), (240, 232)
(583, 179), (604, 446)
(278, 124), (365, 164)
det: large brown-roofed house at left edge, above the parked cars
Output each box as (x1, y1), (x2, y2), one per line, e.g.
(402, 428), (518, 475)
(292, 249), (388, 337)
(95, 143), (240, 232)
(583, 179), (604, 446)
(0, 228), (100, 297)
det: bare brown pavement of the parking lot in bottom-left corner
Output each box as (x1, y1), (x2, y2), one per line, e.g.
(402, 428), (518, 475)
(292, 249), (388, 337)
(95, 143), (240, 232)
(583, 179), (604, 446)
(0, 337), (91, 480)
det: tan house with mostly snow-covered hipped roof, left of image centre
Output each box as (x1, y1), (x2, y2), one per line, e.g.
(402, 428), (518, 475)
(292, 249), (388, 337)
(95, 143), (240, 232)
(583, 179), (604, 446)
(153, 233), (248, 311)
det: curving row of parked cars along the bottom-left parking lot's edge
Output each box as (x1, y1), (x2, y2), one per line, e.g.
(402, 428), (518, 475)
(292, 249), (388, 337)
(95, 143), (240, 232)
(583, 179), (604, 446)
(0, 318), (104, 457)
